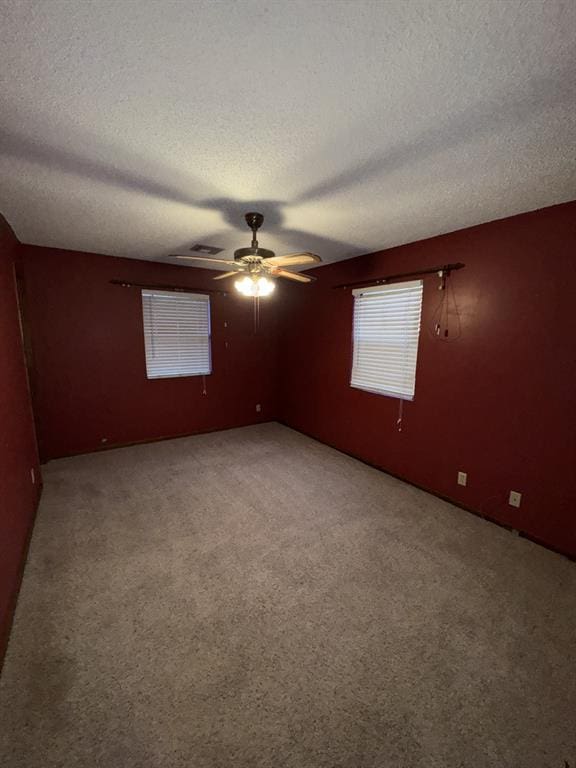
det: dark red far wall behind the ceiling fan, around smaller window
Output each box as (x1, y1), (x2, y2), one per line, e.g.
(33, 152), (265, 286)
(22, 246), (277, 460)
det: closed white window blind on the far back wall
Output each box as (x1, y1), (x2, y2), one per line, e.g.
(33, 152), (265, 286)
(142, 290), (211, 379)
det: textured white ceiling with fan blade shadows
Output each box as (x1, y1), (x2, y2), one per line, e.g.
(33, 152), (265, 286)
(0, 0), (576, 270)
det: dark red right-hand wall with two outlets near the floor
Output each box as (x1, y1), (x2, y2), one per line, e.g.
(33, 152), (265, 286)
(279, 202), (576, 554)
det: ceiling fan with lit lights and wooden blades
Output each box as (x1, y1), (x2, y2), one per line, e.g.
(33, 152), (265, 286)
(173, 212), (322, 297)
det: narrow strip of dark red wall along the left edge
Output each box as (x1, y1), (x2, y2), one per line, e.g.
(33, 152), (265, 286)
(0, 216), (40, 664)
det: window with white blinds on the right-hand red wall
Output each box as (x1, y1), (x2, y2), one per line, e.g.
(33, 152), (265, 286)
(350, 280), (422, 400)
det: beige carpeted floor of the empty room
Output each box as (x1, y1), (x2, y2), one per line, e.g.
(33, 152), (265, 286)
(0, 424), (576, 768)
